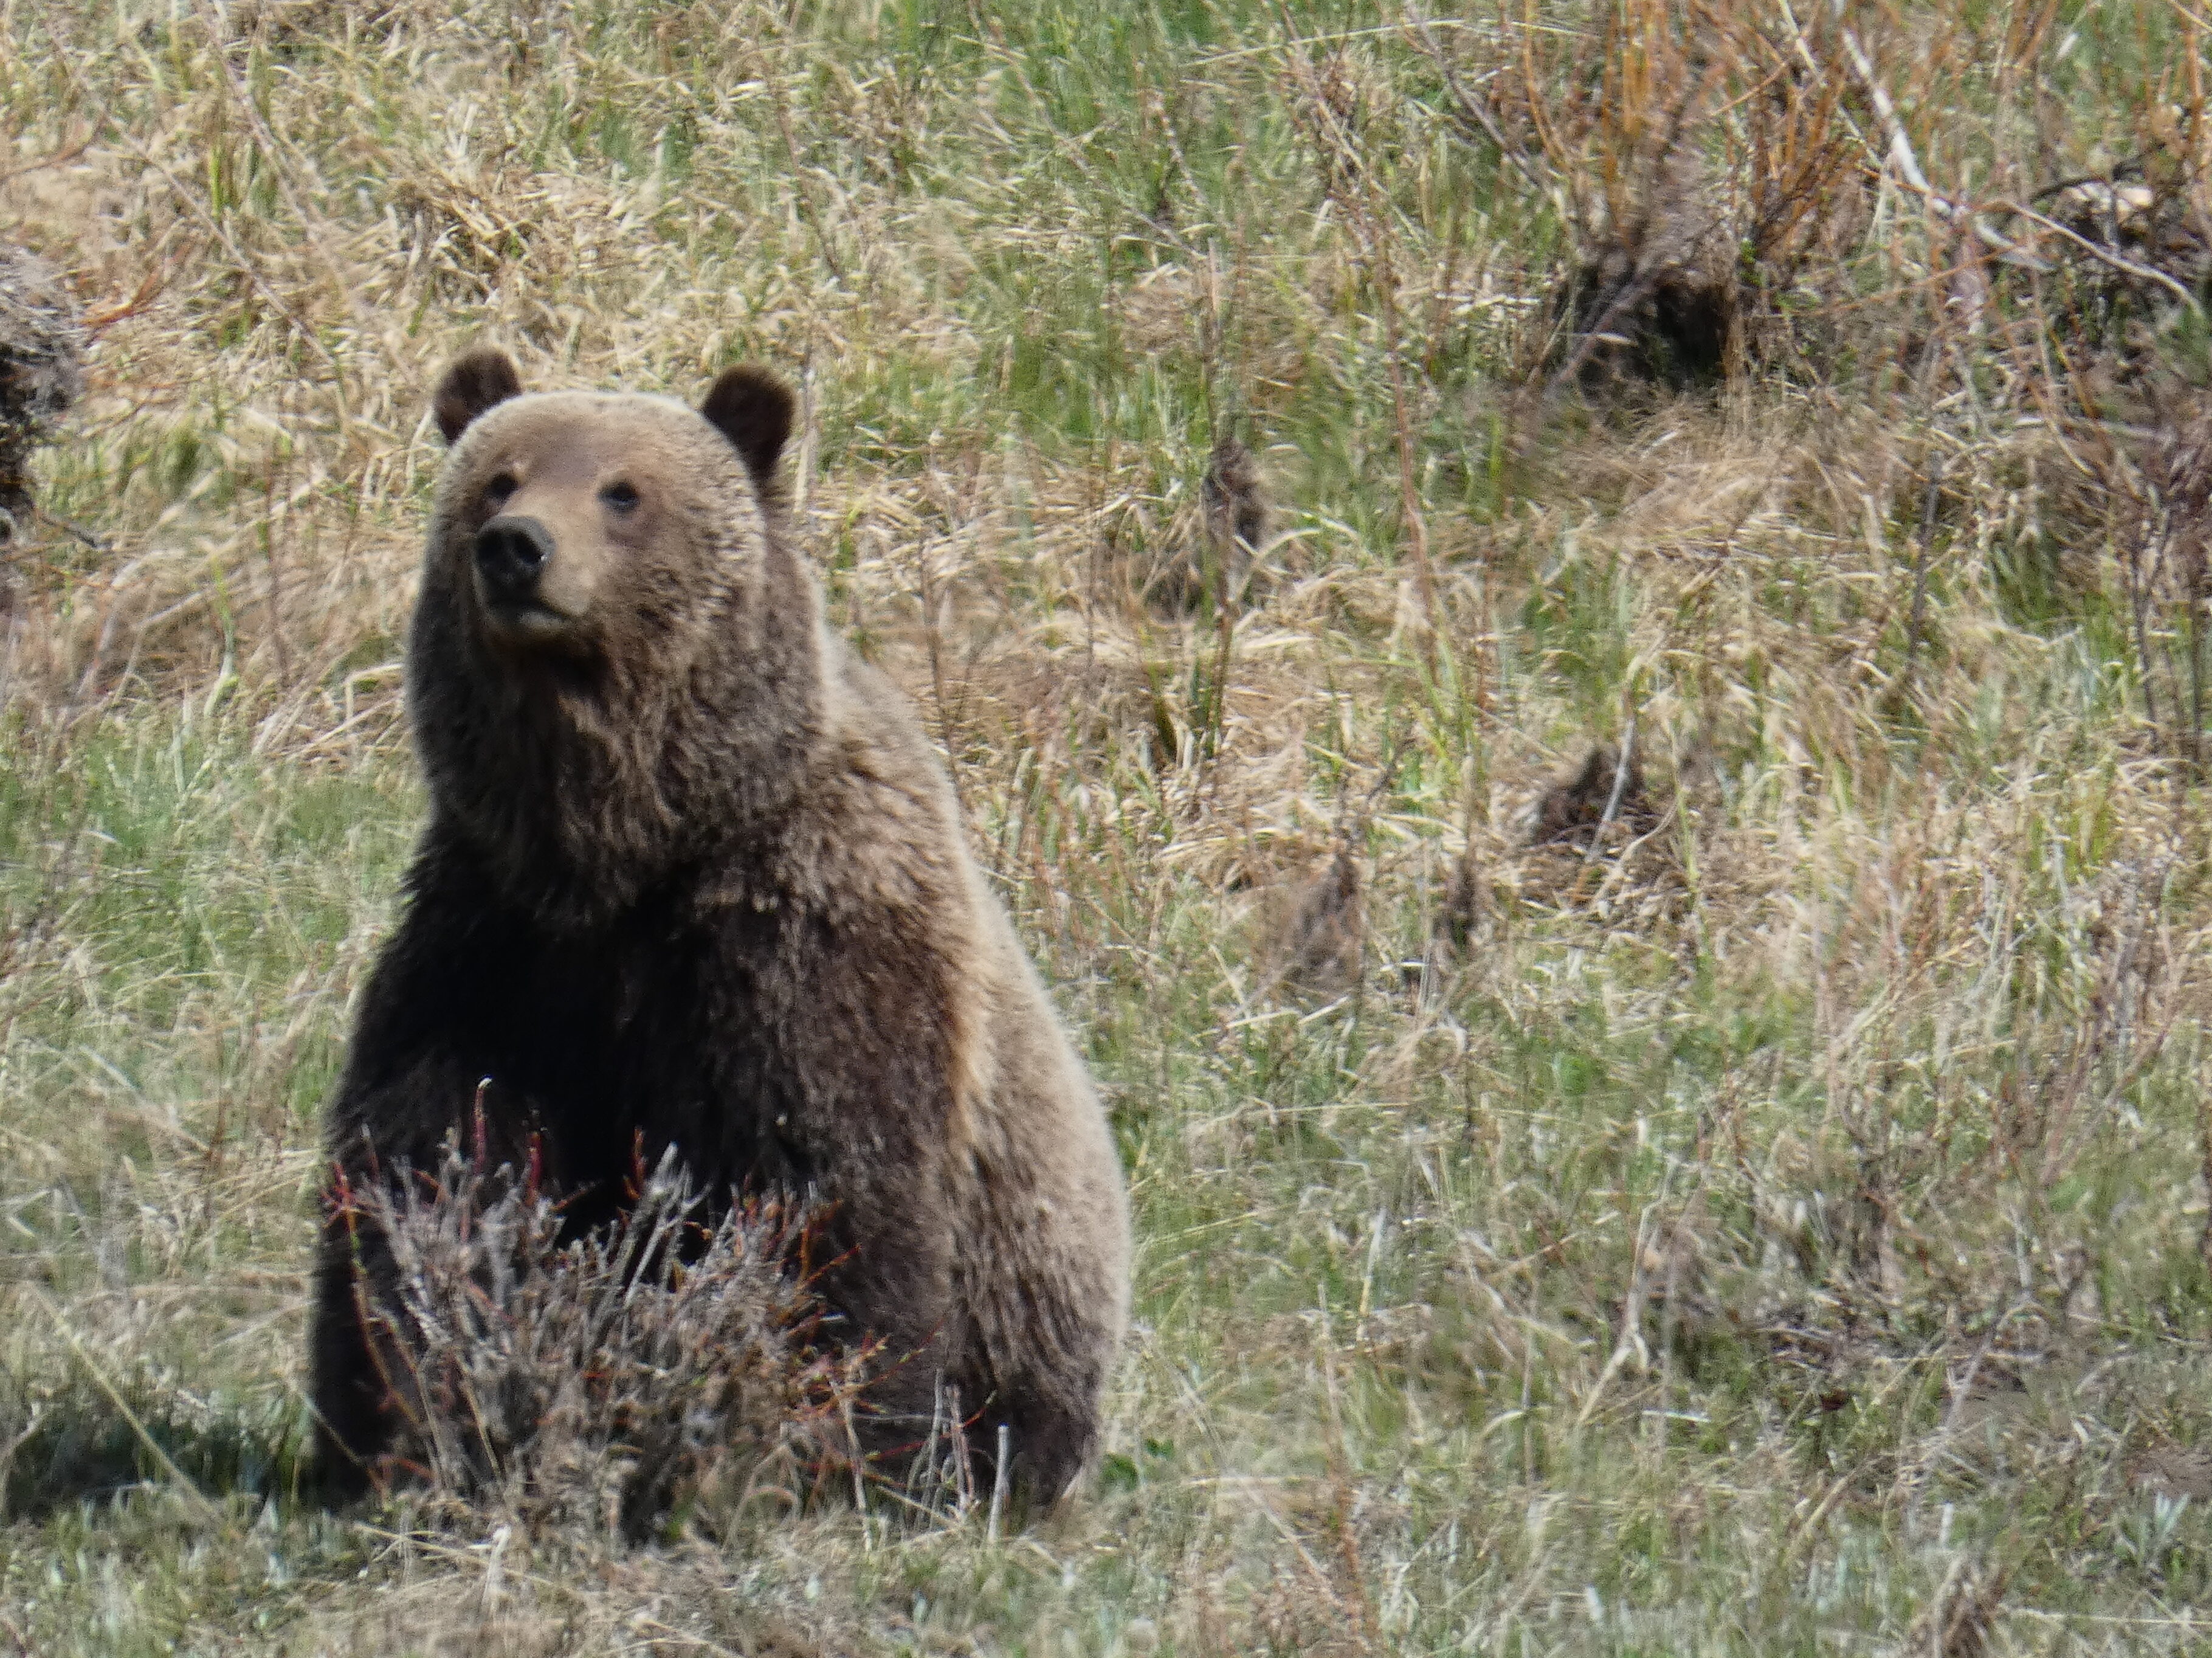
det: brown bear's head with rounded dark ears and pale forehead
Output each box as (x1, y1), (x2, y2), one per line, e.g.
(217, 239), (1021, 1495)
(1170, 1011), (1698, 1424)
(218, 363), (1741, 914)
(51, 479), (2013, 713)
(407, 350), (825, 925)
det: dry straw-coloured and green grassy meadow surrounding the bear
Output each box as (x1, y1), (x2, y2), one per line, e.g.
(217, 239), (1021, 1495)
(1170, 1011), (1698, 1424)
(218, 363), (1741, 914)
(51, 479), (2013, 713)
(0, 0), (2212, 1658)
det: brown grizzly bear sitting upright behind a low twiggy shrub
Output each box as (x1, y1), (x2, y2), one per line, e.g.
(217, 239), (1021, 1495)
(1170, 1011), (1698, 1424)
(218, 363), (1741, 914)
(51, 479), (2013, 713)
(312, 350), (1131, 1505)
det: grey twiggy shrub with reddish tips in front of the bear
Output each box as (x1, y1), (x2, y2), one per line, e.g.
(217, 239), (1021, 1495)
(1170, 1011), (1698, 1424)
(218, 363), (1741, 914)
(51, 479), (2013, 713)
(340, 1142), (865, 1538)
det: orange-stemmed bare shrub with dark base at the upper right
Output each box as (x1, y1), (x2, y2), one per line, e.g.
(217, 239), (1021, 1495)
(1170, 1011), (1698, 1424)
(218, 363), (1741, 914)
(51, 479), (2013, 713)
(1420, 0), (1867, 387)
